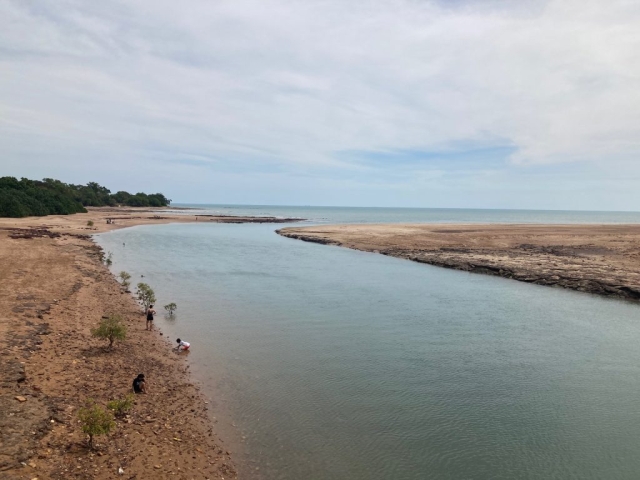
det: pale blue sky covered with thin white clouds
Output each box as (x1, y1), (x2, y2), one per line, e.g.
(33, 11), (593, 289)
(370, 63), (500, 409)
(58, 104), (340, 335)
(0, 0), (640, 211)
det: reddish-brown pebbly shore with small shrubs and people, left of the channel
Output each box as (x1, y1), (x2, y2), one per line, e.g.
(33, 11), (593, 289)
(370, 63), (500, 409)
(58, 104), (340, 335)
(0, 208), (296, 480)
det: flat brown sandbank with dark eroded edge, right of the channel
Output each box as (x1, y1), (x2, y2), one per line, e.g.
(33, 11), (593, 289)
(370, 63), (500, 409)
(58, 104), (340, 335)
(278, 224), (640, 300)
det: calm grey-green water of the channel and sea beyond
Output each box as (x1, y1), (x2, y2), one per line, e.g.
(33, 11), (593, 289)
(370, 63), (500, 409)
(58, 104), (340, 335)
(94, 205), (640, 480)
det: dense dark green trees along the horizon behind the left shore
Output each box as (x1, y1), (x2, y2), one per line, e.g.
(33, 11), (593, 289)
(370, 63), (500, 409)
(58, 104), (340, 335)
(0, 177), (171, 217)
